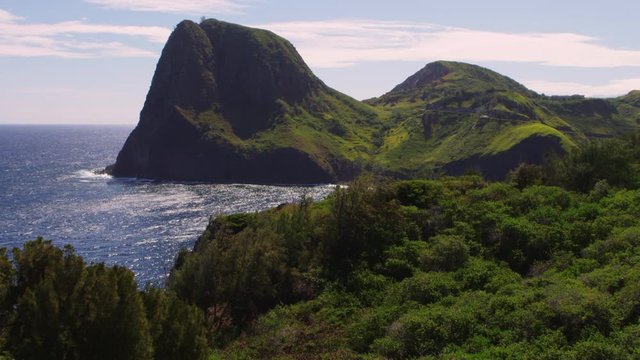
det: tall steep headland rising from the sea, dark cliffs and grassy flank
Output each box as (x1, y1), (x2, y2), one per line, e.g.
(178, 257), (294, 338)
(111, 19), (378, 183)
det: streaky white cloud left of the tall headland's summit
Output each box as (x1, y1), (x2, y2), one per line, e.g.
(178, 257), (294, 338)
(0, 10), (170, 58)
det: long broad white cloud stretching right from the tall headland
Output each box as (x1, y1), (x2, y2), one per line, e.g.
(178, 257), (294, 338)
(259, 20), (640, 68)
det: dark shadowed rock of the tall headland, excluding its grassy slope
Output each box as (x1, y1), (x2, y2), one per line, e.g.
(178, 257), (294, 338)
(110, 20), (362, 183)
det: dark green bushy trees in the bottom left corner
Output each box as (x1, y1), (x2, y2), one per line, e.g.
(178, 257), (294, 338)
(0, 238), (209, 359)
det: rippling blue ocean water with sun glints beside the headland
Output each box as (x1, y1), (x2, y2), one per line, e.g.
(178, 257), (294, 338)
(0, 125), (333, 285)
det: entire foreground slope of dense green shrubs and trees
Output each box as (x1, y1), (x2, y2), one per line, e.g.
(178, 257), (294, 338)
(5, 132), (640, 359)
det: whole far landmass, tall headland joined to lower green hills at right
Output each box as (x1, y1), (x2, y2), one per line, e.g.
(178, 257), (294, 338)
(110, 19), (640, 183)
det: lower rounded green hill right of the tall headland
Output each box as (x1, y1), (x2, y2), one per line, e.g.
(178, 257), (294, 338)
(368, 61), (584, 178)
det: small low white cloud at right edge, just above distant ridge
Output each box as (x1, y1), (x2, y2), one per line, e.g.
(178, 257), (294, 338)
(523, 79), (640, 97)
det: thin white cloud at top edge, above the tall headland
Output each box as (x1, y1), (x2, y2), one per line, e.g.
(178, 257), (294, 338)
(85, 0), (247, 15)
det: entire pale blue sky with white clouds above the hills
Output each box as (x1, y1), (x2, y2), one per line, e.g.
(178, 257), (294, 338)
(0, 0), (640, 126)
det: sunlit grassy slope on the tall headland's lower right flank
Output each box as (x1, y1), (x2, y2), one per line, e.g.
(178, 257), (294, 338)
(183, 91), (381, 173)
